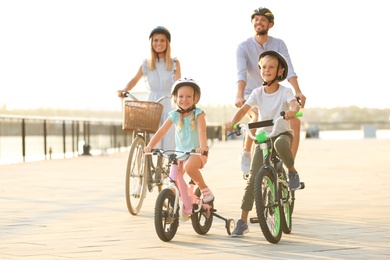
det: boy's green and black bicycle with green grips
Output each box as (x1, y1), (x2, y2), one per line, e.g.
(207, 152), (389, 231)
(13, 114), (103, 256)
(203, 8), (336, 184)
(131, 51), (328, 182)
(233, 112), (305, 244)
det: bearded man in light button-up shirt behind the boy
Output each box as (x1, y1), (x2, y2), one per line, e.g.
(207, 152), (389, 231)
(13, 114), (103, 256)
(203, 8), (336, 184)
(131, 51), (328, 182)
(235, 7), (306, 174)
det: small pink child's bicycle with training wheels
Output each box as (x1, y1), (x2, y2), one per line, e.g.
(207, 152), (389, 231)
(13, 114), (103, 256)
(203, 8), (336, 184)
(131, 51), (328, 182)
(146, 149), (235, 242)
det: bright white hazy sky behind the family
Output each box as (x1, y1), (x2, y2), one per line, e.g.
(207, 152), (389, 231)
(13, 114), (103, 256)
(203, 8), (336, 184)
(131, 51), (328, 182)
(0, 0), (390, 110)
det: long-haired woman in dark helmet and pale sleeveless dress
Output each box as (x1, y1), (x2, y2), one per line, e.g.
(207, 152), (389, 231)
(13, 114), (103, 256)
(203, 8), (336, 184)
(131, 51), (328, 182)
(117, 26), (181, 149)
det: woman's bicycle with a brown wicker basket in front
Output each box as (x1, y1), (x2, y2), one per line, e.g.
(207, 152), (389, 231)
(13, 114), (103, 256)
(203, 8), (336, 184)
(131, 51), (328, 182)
(122, 92), (171, 215)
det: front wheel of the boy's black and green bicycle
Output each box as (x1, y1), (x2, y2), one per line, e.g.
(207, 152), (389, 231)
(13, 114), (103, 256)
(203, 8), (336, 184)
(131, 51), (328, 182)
(254, 170), (282, 244)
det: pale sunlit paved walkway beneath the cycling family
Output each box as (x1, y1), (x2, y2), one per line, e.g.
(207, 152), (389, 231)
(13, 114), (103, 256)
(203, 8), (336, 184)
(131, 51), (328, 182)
(0, 139), (390, 259)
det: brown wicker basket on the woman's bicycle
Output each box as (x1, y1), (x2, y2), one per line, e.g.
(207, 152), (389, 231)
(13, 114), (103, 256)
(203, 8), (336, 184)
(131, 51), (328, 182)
(122, 100), (163, 133)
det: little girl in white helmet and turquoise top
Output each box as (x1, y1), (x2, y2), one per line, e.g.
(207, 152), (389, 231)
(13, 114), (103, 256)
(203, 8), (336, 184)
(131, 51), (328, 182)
(144, 78), (214, 203)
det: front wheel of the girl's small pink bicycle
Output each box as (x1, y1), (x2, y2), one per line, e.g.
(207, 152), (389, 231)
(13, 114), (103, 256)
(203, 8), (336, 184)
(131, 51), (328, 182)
(154, 189), (179, 242)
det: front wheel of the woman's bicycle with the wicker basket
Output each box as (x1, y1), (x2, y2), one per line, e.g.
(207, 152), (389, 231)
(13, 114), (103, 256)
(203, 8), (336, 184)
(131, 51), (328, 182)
(126, 136), (148, 215)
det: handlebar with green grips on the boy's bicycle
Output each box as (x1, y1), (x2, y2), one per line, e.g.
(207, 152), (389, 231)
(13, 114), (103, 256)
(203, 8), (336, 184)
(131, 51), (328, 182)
(233, 111), (303, 143)
